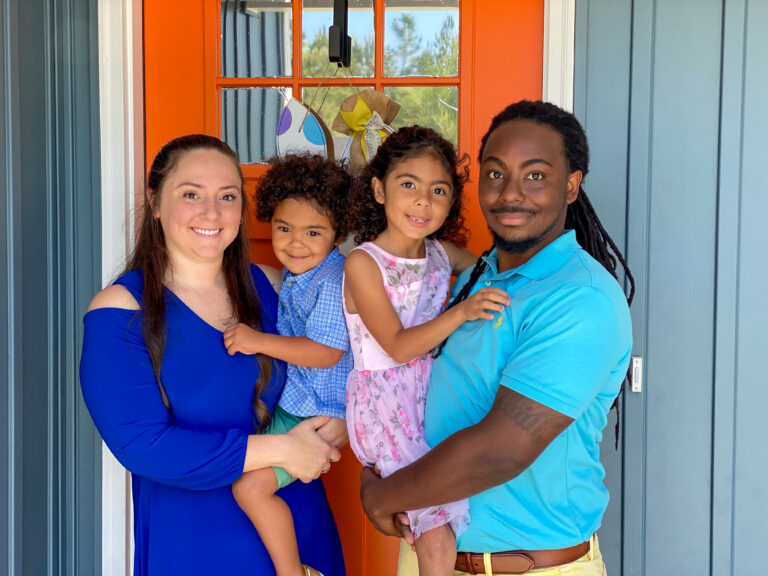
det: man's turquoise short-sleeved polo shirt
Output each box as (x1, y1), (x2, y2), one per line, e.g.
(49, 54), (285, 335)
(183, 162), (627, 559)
(425, 230), (632, 552)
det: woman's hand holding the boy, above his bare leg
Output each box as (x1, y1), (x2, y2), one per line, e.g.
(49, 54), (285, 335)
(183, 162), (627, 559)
(279, 416), (341, 482)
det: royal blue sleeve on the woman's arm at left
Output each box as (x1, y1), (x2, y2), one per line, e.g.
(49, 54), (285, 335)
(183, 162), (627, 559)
(80, 308), (248, 490)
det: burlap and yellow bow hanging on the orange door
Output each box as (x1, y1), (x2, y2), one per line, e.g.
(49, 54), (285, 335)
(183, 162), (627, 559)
(332, 89), (400, 171)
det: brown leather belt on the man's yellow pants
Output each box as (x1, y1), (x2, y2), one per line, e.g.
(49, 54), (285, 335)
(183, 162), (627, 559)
(456, 541), (589, 574)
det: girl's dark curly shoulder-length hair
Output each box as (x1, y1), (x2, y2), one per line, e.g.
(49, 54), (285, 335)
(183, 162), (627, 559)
(351, 126), (469, 246)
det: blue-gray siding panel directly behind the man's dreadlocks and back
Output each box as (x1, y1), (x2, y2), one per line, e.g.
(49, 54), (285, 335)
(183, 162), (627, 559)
(574, 0), (634, 569)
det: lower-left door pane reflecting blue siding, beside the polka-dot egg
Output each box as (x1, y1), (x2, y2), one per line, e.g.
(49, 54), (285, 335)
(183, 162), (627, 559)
(221, 88), (290, 164)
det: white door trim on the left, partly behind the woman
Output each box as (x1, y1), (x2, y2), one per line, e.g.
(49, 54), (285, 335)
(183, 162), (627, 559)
(98, 0), (144, 576)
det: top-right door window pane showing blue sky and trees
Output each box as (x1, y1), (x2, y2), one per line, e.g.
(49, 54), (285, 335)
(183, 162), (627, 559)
(384, 0), (459, 77)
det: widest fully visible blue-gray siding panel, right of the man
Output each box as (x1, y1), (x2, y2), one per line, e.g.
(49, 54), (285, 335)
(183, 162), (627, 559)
(644, 0), (722, 574)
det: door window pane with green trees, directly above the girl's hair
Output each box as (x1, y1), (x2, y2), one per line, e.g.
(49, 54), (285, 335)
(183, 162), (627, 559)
(384, 86), (459, 146)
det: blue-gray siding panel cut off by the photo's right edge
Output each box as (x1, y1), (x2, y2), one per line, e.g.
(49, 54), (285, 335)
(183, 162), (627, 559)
(730, 0), (768, 576)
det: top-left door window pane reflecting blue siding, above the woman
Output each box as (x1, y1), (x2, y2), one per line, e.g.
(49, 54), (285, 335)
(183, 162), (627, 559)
(221, 0), (293, 78)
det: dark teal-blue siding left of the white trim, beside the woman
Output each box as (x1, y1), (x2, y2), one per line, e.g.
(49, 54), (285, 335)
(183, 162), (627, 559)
(0, 0), (101, 575)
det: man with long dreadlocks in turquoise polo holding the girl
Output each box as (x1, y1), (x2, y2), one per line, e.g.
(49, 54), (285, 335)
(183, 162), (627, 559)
(361, 102), (633, 576)
